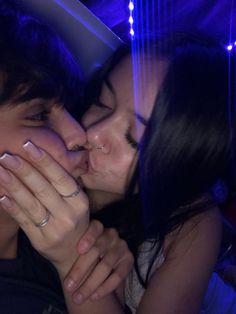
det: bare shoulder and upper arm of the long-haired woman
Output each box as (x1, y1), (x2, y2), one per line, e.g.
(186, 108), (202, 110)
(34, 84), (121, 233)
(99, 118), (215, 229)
(138, 207), (221, 314)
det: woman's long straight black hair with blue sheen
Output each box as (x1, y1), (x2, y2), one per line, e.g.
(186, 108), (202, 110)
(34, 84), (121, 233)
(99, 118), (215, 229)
(93, 34), (235, 286)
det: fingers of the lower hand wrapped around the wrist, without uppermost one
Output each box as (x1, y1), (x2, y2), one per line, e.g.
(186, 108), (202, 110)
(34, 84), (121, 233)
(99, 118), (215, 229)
(64, 229), (133, 304)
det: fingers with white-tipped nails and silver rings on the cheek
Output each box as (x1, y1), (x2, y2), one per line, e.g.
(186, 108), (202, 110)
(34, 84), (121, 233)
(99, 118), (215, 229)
(0, 142), (88, 219)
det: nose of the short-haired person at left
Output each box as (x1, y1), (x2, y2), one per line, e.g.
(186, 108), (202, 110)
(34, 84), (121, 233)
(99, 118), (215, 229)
(59, 111), (87, 150)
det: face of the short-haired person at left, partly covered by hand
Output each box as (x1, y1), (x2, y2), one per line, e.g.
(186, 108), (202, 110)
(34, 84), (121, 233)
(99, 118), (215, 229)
(0, 99), (87, 178)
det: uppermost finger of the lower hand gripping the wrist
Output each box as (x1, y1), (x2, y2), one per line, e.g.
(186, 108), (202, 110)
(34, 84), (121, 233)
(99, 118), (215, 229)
(77, 220), (104, 254)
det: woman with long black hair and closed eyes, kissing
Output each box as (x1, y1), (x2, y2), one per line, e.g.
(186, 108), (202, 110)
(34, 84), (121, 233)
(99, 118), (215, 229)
(1, 5), (236, 314)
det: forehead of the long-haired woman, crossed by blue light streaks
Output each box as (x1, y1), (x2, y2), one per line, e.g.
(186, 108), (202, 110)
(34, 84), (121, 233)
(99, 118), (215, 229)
(109, 55), (168, 118)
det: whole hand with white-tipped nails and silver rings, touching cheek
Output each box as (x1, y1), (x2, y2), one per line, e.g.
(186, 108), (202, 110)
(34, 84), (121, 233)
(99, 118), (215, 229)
(0, 143), (89, 270)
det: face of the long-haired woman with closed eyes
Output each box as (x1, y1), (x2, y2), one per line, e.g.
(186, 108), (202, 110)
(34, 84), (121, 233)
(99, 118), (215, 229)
(81, 56), (167, 195)
